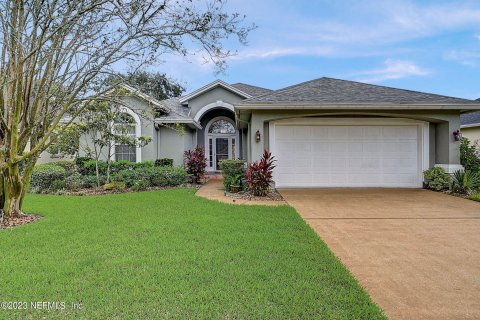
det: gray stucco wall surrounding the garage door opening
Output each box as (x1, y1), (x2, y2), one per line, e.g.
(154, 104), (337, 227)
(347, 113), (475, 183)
(246, 110), (460, 165)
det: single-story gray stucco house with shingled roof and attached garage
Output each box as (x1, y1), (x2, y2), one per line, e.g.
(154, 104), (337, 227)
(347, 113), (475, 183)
(41, 78), (480, 187)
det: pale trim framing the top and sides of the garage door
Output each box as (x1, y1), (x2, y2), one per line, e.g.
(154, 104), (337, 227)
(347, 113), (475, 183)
(269, 117), (430, 188)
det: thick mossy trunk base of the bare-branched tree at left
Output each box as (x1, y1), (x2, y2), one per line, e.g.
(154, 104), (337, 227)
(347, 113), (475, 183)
(2, 163), (25, 217)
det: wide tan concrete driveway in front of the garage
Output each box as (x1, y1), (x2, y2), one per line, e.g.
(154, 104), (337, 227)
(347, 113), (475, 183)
(279, 189), (480, 319)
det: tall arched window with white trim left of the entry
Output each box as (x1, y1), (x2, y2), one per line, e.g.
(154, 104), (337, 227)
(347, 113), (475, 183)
(115, 113), (137, 162)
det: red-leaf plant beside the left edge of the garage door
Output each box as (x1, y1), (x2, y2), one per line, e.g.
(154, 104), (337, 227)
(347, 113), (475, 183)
(246, 150), (276, 197)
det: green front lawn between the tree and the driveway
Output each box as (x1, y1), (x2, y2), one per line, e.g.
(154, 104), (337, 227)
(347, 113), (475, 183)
(0, 189), (385, 319)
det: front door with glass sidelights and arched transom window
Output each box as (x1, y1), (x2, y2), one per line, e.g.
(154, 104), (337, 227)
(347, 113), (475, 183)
(205, 116), (239, 171)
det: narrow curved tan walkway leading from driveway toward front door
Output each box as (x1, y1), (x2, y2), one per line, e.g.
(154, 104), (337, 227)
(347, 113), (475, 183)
(196, 178), (286, 206)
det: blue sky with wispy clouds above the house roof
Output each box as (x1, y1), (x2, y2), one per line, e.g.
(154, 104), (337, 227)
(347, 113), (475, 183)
(155, 0), (480, 99)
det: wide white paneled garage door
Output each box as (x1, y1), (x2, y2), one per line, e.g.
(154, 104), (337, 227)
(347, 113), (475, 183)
(272, 125), (421, 187)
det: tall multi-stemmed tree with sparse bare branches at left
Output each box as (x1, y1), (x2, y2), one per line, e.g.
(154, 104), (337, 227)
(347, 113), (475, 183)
(0, 0), (253, 216)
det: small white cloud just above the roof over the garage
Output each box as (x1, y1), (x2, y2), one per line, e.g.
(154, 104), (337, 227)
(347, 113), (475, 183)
(351, 59), (431, 82)
